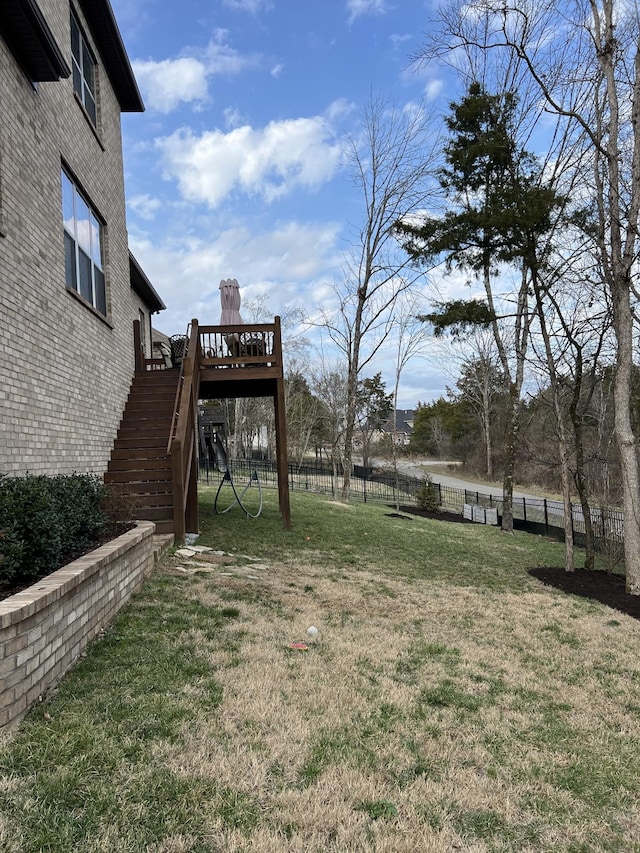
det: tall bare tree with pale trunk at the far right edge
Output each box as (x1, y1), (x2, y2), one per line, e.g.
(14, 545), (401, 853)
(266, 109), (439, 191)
(420, 0), (640, 595)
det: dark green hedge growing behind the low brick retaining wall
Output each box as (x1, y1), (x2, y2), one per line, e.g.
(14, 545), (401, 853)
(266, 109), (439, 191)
(0, 474), (110, 586)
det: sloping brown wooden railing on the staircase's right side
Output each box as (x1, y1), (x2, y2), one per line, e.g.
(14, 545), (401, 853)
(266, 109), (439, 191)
(167, 319), (201, 542)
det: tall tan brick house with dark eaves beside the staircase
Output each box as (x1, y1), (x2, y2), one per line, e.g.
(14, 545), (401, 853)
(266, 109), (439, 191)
(0, 0), (165, 474)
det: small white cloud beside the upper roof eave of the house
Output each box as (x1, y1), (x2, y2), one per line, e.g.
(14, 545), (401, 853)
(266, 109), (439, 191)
(132, 57), (208, 113)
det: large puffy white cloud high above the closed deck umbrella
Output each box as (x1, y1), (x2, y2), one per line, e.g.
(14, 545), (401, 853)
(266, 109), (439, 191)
(156, 109), (342, 208)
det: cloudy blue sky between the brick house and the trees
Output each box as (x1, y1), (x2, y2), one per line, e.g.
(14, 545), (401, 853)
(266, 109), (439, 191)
(111, 0), (458, 408)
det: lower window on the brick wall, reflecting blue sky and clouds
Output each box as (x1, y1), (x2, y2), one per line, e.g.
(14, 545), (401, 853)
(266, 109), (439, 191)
(62, 170), (107, 317)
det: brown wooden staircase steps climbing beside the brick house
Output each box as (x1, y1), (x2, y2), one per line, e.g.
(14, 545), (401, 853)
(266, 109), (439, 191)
(104, 369), (180, 533)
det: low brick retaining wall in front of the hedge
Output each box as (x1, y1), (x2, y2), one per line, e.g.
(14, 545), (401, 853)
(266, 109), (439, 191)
(0, 521), (156, 729)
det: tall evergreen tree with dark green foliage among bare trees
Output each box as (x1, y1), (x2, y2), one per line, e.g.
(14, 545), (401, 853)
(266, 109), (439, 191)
(398, 82), (559, 531)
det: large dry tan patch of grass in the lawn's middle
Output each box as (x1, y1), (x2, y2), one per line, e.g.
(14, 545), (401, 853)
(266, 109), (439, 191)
(144, 548), (640, 853)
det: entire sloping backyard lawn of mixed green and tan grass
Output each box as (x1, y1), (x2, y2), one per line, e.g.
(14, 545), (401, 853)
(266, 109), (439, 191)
(0, 488), (640, 853)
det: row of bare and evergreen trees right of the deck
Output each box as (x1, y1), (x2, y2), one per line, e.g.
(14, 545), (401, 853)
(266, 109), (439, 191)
(206, 0), (640, 594)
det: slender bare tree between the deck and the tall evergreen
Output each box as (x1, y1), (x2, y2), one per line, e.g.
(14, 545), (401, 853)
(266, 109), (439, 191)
(321, 96), (437, 500)
